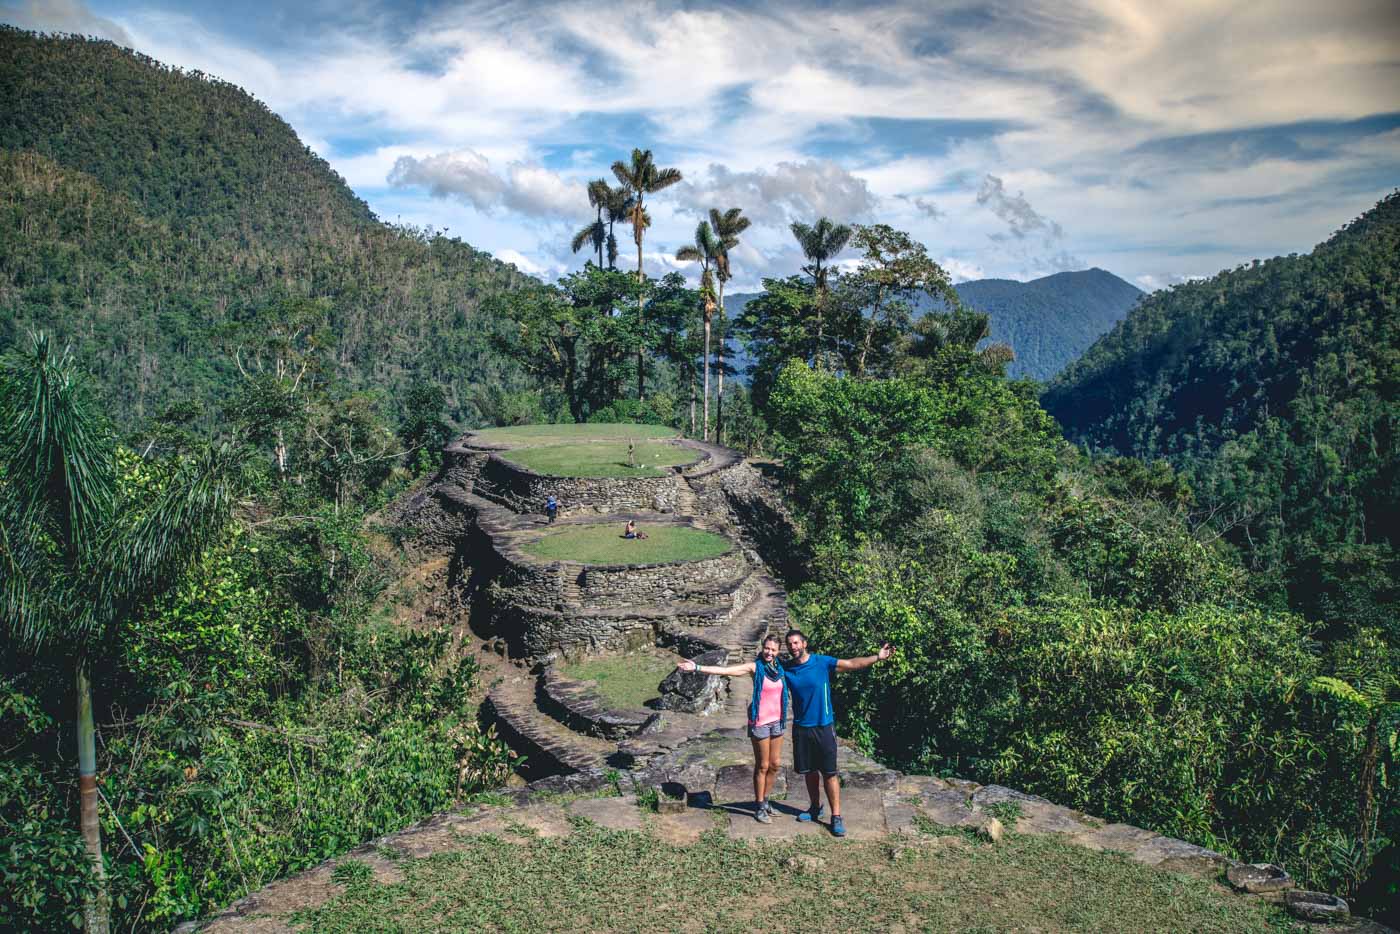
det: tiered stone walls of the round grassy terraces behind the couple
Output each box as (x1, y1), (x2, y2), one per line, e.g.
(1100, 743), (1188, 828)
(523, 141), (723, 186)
(399, 435), (794, 776)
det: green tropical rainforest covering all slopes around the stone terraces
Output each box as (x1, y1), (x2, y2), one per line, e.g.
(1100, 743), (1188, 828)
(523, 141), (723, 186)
(0, 29), (1400, 930)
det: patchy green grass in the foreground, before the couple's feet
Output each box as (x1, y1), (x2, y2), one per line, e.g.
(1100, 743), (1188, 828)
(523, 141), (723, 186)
(293, 818), (1288, 934)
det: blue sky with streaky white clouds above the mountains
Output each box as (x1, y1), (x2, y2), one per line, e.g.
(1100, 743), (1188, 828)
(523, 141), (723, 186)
(8, 0), (1400, 291)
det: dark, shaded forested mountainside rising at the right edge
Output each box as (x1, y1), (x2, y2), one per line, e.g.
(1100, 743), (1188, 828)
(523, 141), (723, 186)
(1043, 193), (1400, 627)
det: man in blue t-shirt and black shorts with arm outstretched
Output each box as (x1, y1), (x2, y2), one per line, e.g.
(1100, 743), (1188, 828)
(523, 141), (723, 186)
(783, 629), (895, 837)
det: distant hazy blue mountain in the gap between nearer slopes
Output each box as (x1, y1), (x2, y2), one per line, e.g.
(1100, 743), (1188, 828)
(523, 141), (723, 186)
(724, 267), (1142, 381)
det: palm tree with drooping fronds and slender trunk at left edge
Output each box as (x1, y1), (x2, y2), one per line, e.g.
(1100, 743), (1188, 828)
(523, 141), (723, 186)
(0, 333), (234, 931)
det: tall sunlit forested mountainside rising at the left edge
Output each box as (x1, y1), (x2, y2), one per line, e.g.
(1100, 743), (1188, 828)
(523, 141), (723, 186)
(0, 27), (526, 426)
